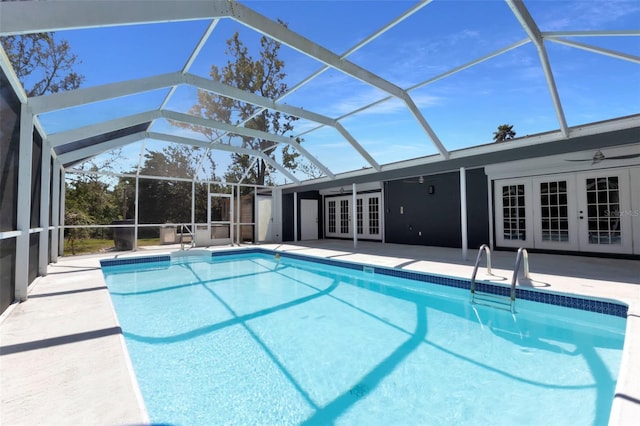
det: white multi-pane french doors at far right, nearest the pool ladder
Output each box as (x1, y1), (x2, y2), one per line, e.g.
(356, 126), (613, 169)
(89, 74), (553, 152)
(494, 169), (639, 253)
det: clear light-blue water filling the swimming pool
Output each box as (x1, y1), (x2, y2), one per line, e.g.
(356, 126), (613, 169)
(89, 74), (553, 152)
(103, 254), (626, 425)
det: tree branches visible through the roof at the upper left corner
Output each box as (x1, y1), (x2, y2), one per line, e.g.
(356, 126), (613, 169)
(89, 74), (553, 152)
(2, 33), (84, 97)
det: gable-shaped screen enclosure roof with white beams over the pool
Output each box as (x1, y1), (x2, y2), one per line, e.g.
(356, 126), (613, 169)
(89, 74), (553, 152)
(0, 0), (640, 184)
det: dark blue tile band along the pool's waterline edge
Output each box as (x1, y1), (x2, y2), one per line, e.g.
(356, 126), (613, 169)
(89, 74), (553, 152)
(100, 247), (629, 318)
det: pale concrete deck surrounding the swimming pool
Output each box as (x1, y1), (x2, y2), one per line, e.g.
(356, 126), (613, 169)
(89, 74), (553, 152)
(0, 240), (640, 425)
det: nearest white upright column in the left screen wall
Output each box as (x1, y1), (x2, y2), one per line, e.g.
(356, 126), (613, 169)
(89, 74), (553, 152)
(14, 104), (33, 301)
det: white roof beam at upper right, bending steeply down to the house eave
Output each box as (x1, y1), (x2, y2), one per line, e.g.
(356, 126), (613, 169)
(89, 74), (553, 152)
(505, 0), (569, 138)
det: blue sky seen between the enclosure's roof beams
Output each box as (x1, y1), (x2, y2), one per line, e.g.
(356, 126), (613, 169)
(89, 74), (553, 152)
(35, 0), (640, 181)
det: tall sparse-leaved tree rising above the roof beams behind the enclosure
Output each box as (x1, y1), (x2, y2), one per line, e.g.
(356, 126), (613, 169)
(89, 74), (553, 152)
(175, 26), (300, 185)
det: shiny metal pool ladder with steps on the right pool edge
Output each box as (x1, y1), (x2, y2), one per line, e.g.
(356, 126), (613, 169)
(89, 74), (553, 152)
(471, 244), (529, 313)
